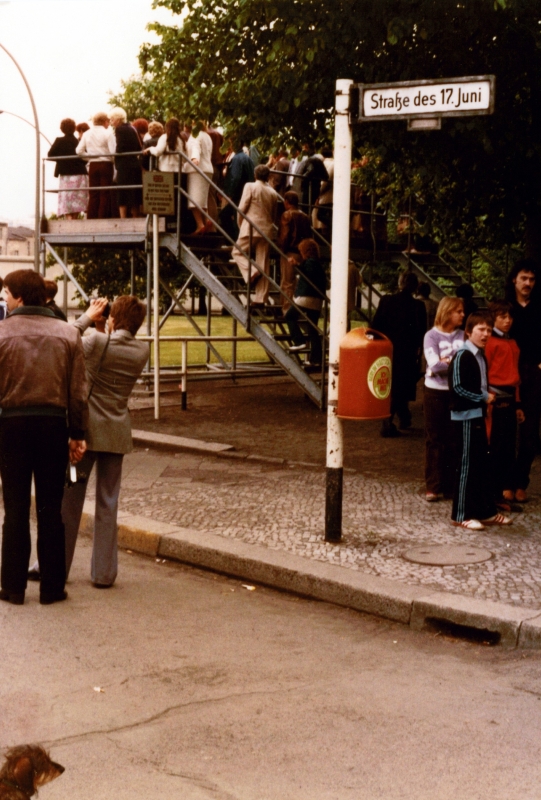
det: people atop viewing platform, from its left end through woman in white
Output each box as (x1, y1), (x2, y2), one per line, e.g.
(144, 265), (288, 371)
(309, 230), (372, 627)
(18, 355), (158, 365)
(48, 108), (223, 234)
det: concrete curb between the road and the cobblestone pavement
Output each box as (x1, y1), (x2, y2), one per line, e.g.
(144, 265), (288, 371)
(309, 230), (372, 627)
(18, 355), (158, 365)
(74, 502), (541, 649)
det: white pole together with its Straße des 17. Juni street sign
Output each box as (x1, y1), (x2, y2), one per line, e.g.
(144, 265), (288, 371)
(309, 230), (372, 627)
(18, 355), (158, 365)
(325, 75), (495, 542)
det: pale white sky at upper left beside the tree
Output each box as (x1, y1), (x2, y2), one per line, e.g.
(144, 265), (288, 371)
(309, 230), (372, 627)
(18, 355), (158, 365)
(0, 0), (178, 227)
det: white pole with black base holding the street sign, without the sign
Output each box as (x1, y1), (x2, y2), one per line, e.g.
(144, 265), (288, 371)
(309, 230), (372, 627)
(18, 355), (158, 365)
(325, 80), (353, 542)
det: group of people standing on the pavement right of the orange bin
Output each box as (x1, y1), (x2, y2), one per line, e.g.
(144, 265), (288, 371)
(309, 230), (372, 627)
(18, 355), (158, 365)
(372, 259), (541, 530)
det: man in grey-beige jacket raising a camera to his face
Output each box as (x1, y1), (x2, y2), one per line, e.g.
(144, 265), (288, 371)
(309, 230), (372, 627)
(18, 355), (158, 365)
(62, 295), (149, 589)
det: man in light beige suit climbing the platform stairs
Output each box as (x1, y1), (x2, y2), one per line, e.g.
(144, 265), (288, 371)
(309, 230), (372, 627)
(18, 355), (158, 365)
(232, 164), (280, 306)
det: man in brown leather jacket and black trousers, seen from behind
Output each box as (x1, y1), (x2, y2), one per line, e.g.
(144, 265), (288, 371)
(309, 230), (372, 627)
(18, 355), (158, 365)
(0, 269), (88, 605)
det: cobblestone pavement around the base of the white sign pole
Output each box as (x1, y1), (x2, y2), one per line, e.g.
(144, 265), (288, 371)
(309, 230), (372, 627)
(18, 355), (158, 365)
(79, 449), (541, 608)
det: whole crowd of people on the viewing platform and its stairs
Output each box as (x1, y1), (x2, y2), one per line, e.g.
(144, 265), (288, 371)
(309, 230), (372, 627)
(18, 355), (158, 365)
(48, 108), (334, 366)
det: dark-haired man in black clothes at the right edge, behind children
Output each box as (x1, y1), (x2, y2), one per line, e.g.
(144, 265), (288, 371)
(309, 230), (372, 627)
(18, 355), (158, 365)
(506, 258), (541, 503)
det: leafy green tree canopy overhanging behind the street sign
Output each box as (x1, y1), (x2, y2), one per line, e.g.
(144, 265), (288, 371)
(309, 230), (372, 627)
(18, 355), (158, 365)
(113, 0), (541, 251)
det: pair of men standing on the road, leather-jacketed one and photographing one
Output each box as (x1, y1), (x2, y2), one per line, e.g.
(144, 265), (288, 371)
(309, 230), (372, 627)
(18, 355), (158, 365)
(0, 269), (149, 605)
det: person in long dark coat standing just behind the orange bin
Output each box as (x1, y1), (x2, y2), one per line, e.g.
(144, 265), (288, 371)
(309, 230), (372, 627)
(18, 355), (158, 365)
(372, 272), (426, 437)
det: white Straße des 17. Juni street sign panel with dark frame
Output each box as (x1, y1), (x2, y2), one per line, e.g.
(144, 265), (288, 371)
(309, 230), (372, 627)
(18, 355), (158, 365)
(352, 75), (495, 122)
